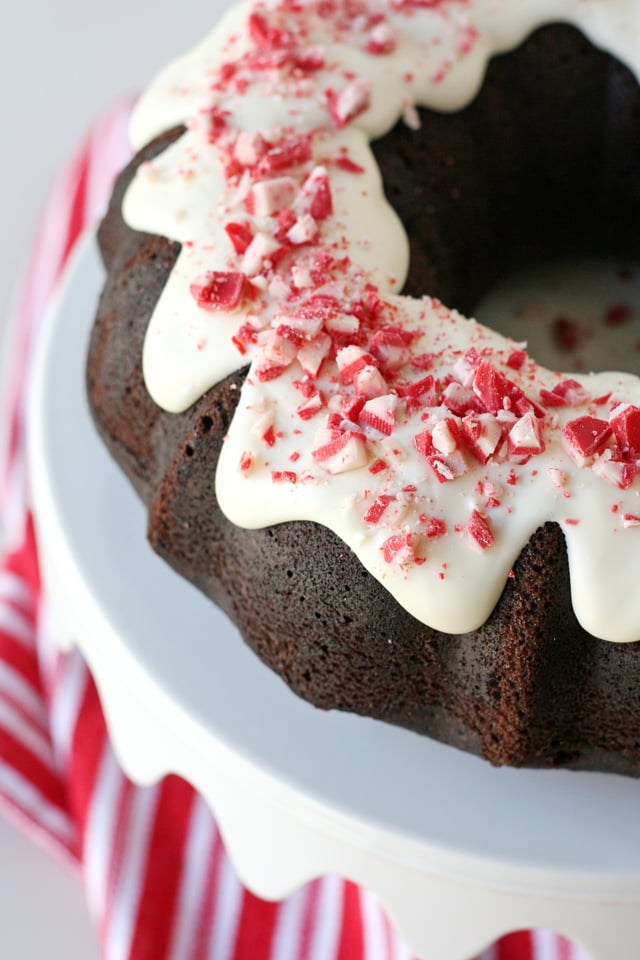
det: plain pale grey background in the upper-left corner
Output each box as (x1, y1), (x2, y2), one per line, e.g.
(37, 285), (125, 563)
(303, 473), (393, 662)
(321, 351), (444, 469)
(0, 0), (225, 344)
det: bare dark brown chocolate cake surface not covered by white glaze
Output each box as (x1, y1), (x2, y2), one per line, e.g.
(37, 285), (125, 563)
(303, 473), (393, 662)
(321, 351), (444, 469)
(87, 13), (640, 775)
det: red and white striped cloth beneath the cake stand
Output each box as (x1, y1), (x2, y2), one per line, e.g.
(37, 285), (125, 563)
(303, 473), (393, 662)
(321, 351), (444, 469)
(0, 104), (581, 960)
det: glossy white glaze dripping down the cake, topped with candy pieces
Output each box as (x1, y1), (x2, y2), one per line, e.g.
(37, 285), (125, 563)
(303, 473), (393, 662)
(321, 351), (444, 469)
(124, 0), (640, 641)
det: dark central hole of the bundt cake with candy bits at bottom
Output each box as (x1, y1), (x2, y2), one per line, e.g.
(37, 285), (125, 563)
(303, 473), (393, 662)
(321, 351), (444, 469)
(373, 24), (640, 373)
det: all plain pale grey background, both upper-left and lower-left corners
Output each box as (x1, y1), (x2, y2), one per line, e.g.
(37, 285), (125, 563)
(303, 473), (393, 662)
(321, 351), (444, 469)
(0, 0), (224, 960)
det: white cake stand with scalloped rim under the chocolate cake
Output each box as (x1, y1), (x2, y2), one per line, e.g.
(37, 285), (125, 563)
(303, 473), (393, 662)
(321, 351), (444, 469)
(30, 239), (640, 960)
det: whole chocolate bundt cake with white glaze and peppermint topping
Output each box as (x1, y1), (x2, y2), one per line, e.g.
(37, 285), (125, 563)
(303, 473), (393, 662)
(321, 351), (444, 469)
(87, 0), (640, 775)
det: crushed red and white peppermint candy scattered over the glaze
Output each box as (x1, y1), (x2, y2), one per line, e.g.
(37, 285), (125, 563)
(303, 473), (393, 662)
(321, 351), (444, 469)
(124, 0), (640, 640)
